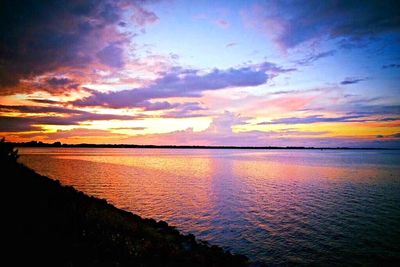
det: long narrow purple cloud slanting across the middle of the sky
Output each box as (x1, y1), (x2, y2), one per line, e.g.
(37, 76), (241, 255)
(72, 62), (278, 108)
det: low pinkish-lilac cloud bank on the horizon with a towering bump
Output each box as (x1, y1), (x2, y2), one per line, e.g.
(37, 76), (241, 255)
(125, 112), (399, 147)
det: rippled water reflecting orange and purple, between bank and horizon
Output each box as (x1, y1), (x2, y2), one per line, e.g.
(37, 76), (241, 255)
(20, 148), (400, 266)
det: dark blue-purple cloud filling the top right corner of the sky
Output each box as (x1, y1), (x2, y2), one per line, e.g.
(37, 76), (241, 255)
(244, 0), (400, 48)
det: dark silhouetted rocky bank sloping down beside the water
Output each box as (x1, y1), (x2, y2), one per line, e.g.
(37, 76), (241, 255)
(0, 152), (248, 266)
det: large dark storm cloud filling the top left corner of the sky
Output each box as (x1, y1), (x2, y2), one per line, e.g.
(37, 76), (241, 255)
(0, 0), (156, 87)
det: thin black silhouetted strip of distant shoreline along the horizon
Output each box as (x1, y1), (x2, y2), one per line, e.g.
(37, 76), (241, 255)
(9, 141), (400, 150)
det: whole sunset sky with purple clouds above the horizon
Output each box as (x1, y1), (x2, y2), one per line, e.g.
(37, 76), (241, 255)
(0, 0), (400, 148)
